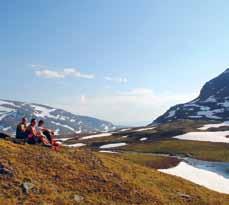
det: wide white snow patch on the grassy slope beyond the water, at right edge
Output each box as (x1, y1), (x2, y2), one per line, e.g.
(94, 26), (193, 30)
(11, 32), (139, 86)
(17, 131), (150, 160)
(173, 131), (229, 143)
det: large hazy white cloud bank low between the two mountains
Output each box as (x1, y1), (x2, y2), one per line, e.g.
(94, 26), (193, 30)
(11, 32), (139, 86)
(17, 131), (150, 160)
(55, 88), (196, 125)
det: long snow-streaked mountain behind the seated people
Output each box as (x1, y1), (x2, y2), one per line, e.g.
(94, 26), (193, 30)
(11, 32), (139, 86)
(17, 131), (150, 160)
(0, 100), (115, 134)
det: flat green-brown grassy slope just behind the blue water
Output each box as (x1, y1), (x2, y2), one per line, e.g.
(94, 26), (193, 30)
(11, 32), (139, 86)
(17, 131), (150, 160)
(120, 139), (229, 162)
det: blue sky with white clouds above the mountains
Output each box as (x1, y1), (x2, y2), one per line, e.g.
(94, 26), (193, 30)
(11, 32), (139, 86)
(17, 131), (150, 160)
(0, 0), (229, 126)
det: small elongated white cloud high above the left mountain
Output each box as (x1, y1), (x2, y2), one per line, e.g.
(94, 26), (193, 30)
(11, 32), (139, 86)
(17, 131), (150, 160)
(31, 64), (94, 79)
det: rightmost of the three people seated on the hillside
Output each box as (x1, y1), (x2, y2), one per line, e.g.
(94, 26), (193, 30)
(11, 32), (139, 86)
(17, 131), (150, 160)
(38, 120), (59, 150)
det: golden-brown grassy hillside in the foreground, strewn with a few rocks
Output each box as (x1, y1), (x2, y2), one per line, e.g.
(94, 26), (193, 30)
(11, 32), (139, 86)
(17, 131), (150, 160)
(0, 140), (229, 205)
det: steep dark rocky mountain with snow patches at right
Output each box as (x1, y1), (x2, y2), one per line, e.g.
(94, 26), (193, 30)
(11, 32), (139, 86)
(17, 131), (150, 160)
(153, 68), (229, 124)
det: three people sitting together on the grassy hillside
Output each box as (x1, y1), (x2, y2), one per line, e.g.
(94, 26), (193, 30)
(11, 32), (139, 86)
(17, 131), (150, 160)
(16, 118), (60, 150)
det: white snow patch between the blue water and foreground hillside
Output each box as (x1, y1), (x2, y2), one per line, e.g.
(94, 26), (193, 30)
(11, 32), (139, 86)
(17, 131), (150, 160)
(159, 162), (229, 194)
